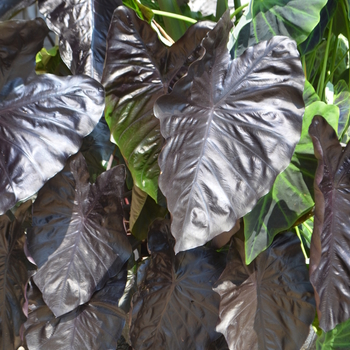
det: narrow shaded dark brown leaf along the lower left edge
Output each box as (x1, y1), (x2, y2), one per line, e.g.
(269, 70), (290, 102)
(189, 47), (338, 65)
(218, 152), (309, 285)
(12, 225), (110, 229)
(0, 201), (31, 350)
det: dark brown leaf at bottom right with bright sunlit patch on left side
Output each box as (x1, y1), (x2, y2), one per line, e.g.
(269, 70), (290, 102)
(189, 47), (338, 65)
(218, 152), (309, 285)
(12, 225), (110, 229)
(214, 232), (315, 350)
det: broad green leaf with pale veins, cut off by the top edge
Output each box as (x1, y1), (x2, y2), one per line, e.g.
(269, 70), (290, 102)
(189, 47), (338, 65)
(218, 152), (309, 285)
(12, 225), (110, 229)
(233, 0), (327, 57)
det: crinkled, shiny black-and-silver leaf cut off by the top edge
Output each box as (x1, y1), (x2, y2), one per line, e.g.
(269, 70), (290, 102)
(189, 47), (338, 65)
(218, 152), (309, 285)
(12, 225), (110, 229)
(38, 0), (122, 81)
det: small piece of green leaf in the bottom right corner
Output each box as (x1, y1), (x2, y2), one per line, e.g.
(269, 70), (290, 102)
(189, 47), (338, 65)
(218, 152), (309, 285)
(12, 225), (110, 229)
(316, 319), (350, 350)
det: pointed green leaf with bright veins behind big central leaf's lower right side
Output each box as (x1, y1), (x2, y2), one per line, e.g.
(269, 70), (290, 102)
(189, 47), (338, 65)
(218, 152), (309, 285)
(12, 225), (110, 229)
(244, 155), (317, 265)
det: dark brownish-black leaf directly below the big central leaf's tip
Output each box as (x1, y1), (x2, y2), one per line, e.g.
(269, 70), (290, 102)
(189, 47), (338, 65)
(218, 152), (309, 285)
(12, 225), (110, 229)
(130, 221), (224, 350)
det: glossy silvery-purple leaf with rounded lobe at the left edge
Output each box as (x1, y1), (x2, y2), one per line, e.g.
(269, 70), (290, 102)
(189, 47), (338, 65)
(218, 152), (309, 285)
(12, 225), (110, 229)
(0, 74), (104, 213)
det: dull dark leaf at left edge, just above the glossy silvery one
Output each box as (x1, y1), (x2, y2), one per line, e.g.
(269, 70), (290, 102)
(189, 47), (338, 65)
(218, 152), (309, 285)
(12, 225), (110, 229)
(0, 18), (48, 95)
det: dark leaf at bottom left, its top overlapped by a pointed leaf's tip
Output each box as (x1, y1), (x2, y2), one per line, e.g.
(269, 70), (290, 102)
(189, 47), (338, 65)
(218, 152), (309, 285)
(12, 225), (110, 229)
(24, 269), (126, 350)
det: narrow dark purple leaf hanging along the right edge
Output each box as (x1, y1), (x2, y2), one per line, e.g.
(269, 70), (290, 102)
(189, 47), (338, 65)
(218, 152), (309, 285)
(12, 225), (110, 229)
(309, 116), (350, 332)
